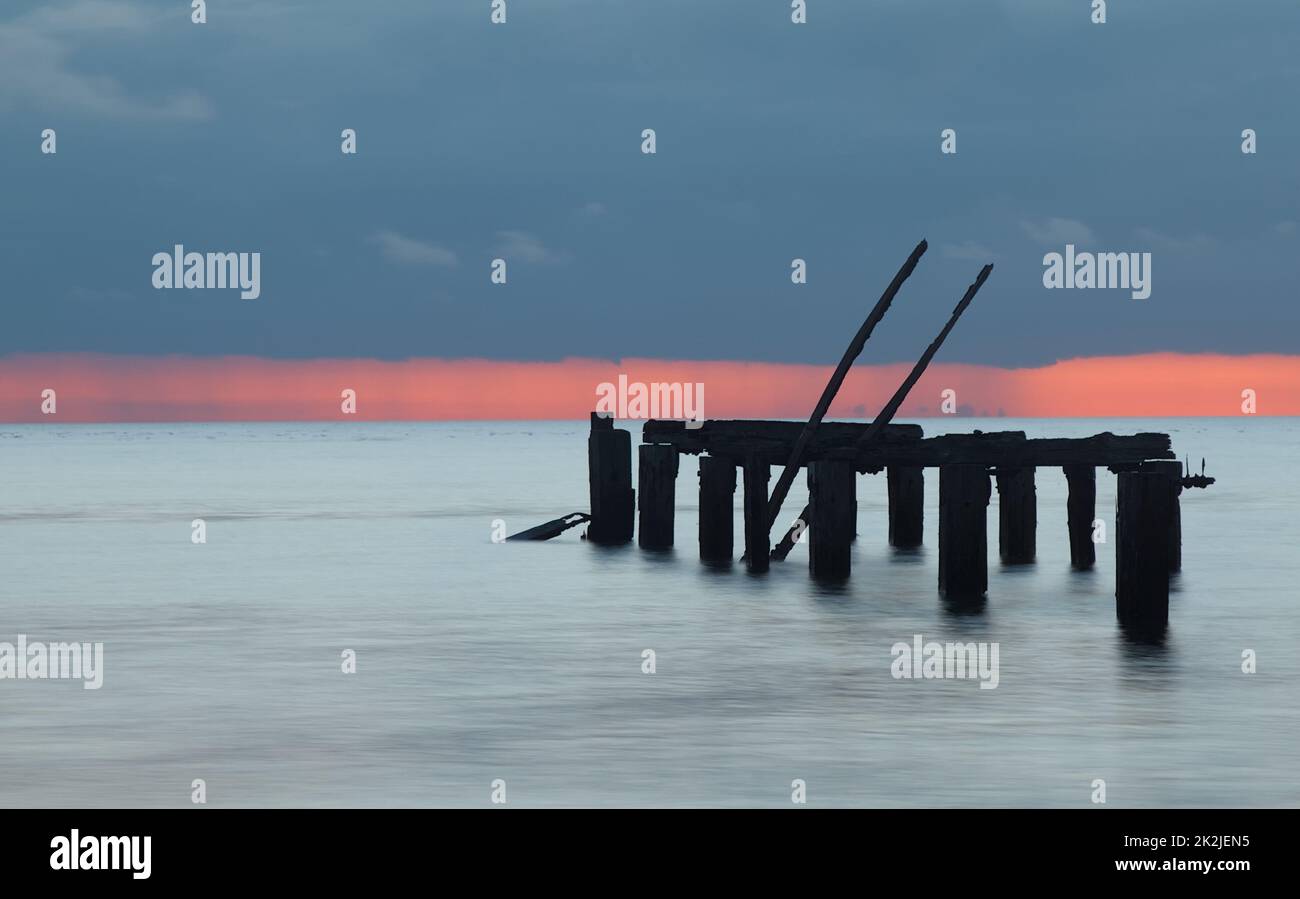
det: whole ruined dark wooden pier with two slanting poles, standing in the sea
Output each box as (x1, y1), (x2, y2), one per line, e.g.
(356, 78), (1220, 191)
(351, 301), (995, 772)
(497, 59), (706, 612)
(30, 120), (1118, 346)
(517, 240), (1214, 635)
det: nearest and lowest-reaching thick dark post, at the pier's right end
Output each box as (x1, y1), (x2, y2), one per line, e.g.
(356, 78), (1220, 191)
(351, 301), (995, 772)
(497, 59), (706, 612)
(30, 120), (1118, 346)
(1115, 472), (1175, 634)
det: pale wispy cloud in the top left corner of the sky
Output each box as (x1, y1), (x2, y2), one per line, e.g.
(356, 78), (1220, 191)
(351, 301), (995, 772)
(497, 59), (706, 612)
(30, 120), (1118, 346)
(0, 0), (213, 120)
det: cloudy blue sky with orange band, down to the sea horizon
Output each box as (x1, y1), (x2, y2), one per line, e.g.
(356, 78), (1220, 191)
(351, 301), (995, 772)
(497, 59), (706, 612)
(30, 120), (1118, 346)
(0, 0), (1300, 420)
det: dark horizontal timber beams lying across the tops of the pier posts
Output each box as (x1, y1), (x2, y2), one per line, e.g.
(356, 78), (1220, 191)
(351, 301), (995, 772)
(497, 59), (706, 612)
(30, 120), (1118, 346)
(641, 420), (1174, 472)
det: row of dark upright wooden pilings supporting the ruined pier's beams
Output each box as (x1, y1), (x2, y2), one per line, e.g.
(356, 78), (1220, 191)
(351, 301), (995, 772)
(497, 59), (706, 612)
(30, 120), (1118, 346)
(586, 416), (1183, 633)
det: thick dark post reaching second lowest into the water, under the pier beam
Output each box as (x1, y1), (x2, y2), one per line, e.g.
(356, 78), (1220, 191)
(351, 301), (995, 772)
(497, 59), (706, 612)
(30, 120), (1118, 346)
(939, 465), (991, 598)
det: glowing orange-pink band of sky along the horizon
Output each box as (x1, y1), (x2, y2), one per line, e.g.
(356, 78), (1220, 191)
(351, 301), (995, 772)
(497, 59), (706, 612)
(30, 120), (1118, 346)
(0, 353), (1300, 422)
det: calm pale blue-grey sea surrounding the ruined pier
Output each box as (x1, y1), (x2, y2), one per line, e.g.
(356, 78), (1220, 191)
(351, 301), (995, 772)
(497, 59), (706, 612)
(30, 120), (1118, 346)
(0, 418), (1300, 807)
